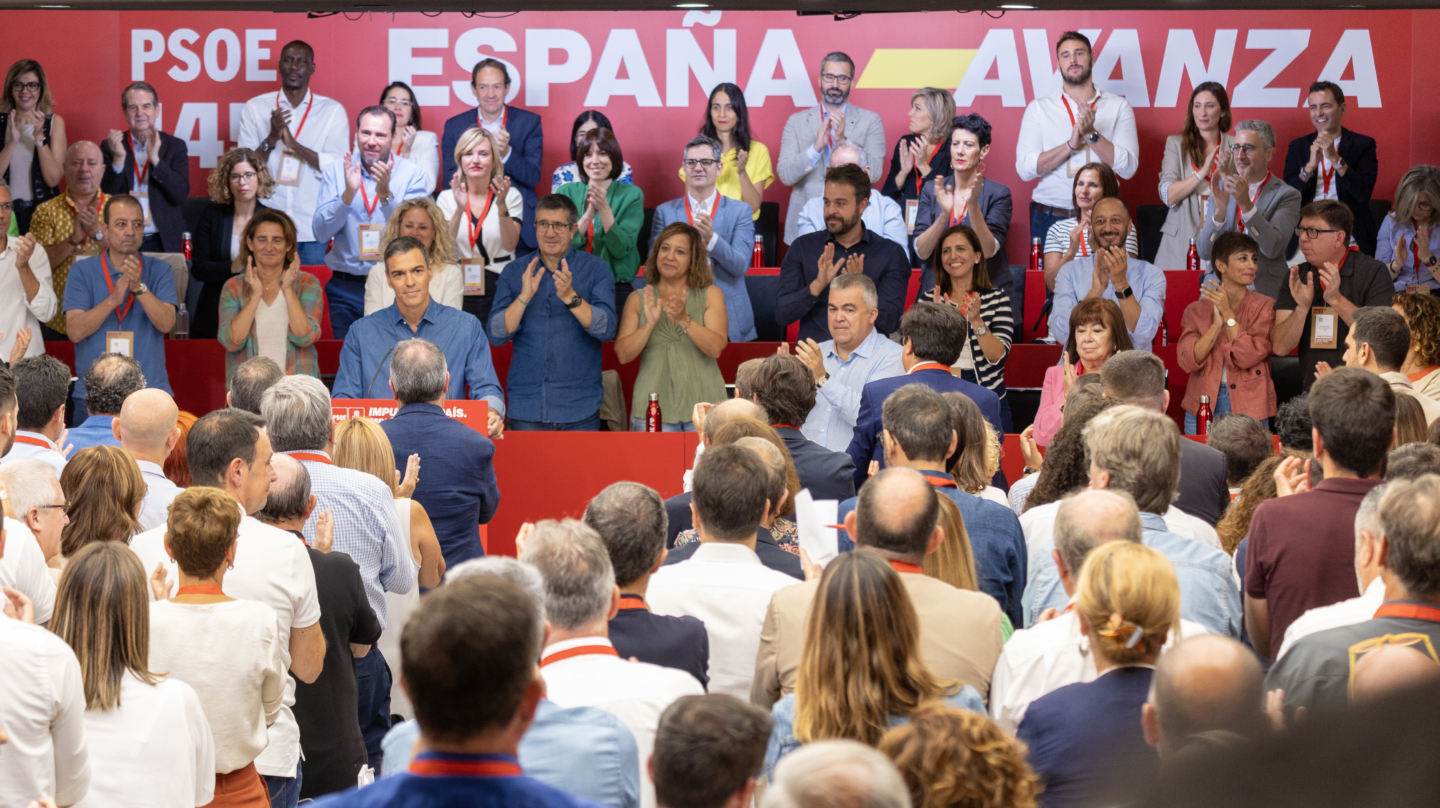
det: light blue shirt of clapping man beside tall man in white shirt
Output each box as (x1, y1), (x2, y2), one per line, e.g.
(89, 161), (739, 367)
(312, 153), (431, 277)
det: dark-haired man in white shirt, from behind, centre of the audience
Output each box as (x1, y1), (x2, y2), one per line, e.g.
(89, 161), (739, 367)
(647, 446), (795, 699)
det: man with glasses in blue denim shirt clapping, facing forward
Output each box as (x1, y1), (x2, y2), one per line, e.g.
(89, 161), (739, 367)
(488, 193), (616, 432)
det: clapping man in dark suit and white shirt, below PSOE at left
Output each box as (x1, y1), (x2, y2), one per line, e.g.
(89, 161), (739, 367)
(99, 81), (190, 252)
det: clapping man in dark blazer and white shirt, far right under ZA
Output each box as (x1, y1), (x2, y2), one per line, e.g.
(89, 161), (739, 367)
(1284, 81), (1380, 255)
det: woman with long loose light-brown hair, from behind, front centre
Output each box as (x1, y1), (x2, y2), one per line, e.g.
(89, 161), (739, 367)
(765, 550), (984, 776)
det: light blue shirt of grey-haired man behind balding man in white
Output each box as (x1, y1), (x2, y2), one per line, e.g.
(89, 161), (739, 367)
(1024, 513), (1244, 638)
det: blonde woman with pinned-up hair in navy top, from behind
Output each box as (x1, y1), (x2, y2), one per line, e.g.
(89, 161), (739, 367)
(1015, 542), (1179, 805)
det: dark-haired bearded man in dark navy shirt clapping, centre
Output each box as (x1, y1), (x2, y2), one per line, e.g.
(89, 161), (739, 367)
(775, 163), (904, 341)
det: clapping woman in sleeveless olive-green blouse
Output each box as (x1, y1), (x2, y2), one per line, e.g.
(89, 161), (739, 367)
(615, 222), (730, 432)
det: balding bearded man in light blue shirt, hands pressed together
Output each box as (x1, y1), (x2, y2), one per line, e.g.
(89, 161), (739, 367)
(1050, 196), (1165, 350)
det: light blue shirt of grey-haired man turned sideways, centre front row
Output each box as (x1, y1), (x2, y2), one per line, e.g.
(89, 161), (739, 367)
(801, 328), (904, 452)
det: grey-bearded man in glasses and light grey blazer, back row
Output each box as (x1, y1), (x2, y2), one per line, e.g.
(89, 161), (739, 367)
(776, 50), (886, 244)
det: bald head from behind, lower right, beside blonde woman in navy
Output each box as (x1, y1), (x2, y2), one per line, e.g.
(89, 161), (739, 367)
(1140, 634), (1269, 760)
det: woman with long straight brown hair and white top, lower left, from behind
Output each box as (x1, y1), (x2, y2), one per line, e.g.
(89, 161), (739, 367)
(49, 542), (215, 808)
